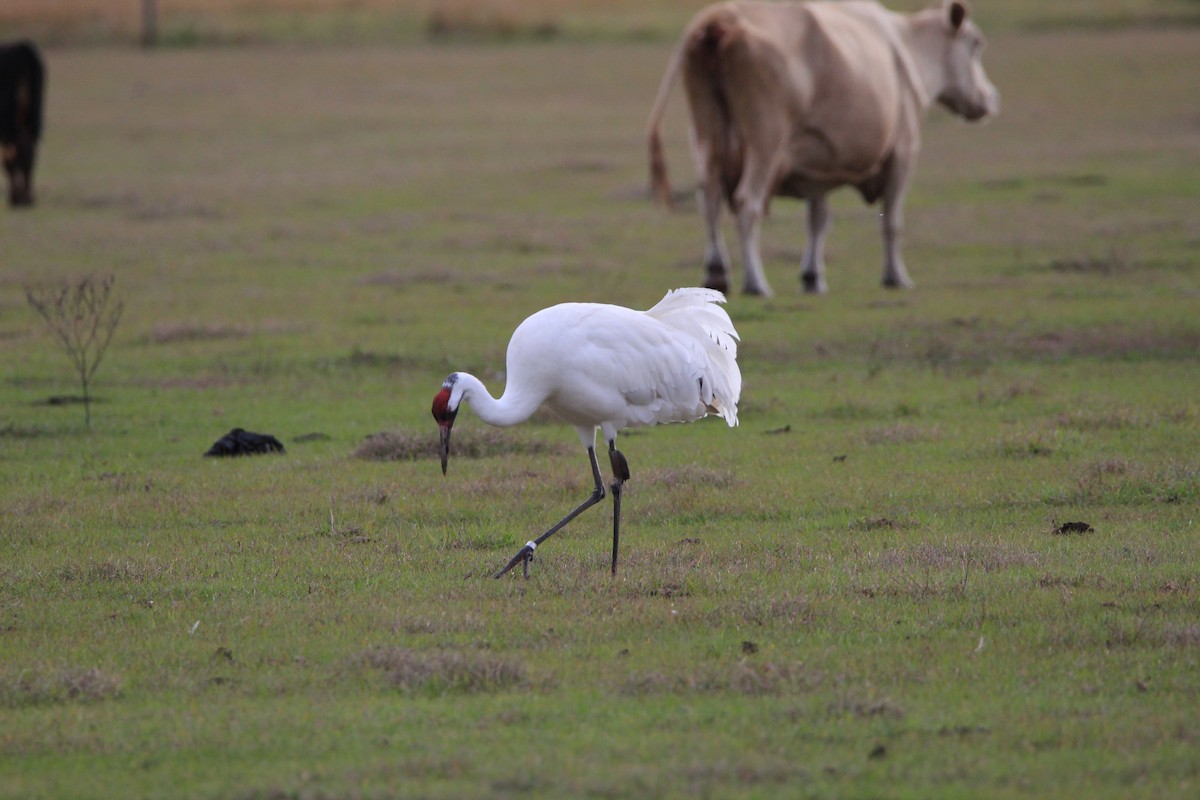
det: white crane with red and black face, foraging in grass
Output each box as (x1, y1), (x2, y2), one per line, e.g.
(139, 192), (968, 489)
(433, 289), (742, 578)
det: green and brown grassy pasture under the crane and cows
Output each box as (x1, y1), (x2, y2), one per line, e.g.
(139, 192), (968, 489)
(0, 2), (1200, 800)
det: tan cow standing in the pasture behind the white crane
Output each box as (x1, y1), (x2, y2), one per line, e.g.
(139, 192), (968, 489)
(649, 0), (1000, 295)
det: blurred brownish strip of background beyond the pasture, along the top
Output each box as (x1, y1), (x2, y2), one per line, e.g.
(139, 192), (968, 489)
(7, 0), (1200, 46)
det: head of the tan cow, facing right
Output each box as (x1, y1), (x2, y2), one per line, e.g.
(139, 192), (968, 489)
(917, 0), (1000, 120)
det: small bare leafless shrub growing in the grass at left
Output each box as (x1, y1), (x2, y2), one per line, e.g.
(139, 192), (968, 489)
(25, 275), (125, 428)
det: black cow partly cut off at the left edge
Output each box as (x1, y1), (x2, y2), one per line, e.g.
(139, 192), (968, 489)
(0, 41), (46, 206)
